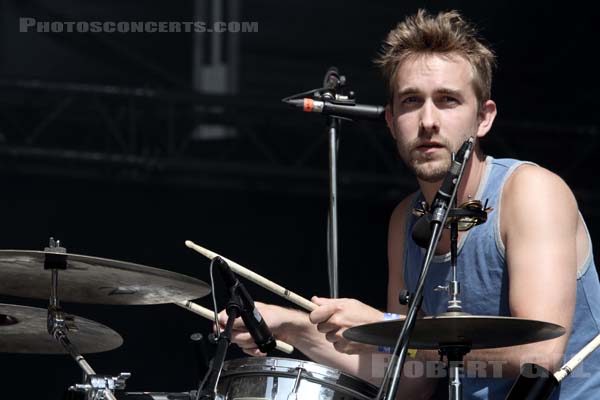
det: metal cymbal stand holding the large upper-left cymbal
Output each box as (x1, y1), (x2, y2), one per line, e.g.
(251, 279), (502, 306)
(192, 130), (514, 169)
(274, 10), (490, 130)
(44, 238), (131, 400)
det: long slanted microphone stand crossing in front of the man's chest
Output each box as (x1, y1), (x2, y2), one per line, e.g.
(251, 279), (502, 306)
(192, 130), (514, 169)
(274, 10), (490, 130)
(375, 139), (471, 400)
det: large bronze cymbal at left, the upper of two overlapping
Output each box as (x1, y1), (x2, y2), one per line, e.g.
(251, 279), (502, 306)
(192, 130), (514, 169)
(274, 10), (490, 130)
(0, 250), (210, 304)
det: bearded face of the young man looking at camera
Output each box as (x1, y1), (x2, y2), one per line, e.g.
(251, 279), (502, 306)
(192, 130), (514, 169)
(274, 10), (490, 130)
(386, 54), (496, 182)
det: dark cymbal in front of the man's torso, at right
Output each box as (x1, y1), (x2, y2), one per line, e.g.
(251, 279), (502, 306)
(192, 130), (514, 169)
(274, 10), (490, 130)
(344, 313), (565, 350)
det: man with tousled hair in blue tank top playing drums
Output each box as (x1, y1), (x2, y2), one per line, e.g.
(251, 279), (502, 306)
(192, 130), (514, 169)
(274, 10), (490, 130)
(222, 10), (600, 399)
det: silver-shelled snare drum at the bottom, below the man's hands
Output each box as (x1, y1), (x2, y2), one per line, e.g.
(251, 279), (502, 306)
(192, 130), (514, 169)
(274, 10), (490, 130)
(218, 357), (377, 400)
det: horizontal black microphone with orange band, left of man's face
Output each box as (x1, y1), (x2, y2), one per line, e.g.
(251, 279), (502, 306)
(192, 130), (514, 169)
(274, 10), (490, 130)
(284, 98), (385, 120)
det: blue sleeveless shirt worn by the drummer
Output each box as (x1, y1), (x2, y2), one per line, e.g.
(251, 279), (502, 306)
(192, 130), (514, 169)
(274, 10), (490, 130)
(404, 157), (600, 400)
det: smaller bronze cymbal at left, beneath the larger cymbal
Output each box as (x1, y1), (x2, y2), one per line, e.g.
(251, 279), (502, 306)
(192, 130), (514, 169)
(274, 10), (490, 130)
(0, 304), (123, 354)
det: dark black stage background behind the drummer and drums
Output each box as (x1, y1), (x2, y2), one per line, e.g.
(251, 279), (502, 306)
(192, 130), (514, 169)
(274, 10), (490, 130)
(0, 0), (600, 399)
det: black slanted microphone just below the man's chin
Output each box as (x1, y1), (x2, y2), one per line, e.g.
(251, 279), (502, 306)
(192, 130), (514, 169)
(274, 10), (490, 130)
(431, 137), (475, 224)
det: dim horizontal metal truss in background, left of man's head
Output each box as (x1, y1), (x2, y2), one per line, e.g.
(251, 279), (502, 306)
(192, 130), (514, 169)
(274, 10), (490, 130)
(0, 81), (414, 200)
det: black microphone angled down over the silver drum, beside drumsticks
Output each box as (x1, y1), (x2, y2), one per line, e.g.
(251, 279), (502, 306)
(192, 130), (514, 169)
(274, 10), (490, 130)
(215, 257), (277, 353)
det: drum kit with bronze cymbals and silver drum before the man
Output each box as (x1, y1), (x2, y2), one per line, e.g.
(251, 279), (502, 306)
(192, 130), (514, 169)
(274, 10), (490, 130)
(0, 234), (580, 400)
